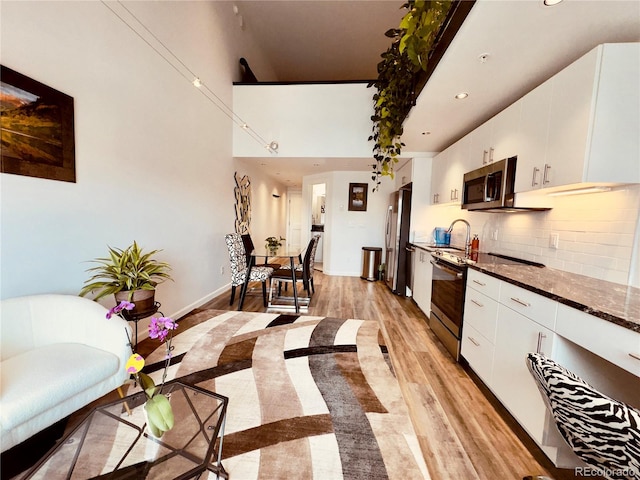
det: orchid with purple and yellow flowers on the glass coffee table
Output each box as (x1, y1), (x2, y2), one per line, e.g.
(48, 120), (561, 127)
(107, 301), (178, 438)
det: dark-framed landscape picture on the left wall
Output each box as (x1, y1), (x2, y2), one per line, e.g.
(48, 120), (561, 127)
(0, 65), (76, 182)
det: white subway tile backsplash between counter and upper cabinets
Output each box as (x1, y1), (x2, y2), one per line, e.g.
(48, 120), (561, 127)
(480, 185), (640, 286)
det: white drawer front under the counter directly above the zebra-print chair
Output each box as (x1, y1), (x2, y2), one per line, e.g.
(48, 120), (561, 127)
(556, 304), (640, 377)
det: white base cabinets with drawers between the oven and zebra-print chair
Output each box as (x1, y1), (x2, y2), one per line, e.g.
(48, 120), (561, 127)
(461, 269), (556, 445)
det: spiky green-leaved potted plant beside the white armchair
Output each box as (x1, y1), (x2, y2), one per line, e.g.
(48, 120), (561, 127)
(80, 241), (171, 313)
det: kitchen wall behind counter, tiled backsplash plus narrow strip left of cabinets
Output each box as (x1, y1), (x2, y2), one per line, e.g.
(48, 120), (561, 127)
(411, 159), (640, 287)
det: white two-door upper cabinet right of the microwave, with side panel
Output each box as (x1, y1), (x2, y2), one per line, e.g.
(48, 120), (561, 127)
(516, 43), (640, 191)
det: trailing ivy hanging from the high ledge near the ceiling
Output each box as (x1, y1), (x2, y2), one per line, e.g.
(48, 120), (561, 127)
(369, 0), (452, 189)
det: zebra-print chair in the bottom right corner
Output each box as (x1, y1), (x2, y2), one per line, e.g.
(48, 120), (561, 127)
(525, 353), (640, 480)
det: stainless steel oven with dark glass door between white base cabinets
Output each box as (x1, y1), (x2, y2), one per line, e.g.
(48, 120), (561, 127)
(429, 252), (467, 361)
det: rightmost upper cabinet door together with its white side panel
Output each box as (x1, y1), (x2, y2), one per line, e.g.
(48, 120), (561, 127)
(544, 43), (640, 187)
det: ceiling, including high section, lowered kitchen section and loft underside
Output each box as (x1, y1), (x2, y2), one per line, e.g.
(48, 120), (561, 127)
(236, 0), (640, 186)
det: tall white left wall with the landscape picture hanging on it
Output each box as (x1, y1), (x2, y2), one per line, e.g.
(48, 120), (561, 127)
(0, 1), (280, 324)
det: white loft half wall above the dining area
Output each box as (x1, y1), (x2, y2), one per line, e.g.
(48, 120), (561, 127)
(233, 83), (374, 158)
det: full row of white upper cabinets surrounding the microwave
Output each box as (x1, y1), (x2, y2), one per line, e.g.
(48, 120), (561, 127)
(431, 43), (640, 194)
